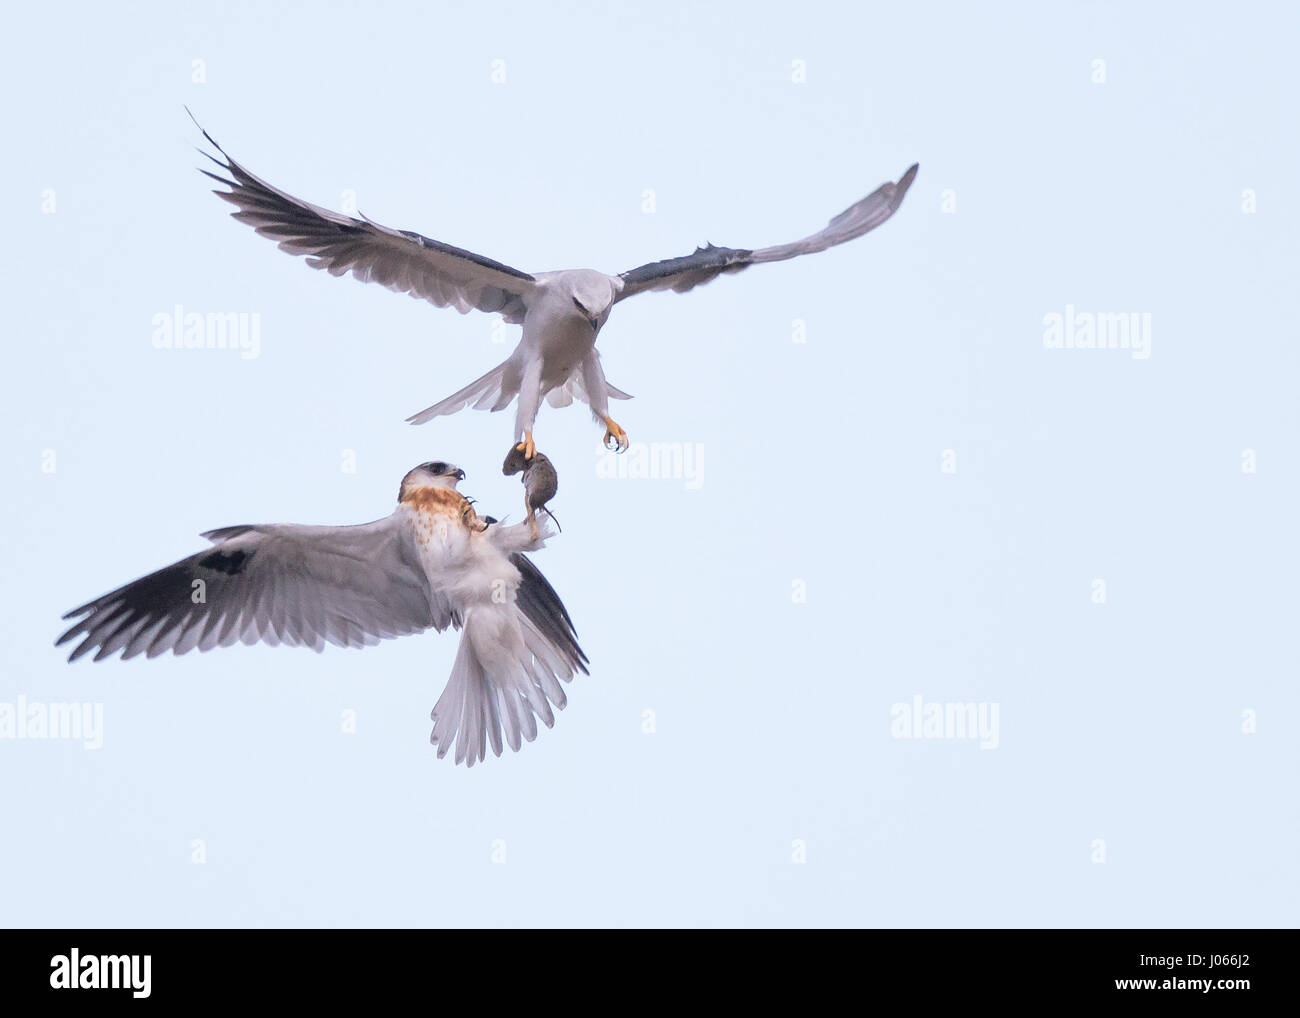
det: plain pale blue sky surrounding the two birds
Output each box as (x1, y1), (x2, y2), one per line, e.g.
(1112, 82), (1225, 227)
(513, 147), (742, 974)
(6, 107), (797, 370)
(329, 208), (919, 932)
(0, 3), (1300, 926)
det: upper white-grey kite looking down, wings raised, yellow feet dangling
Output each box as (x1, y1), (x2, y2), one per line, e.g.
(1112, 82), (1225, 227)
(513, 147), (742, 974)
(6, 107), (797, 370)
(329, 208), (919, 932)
(191, 114), (917, 459)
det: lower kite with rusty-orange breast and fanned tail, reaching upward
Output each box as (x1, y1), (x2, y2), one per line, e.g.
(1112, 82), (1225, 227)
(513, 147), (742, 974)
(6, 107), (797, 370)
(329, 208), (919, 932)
(56, 463), (588, 767)
